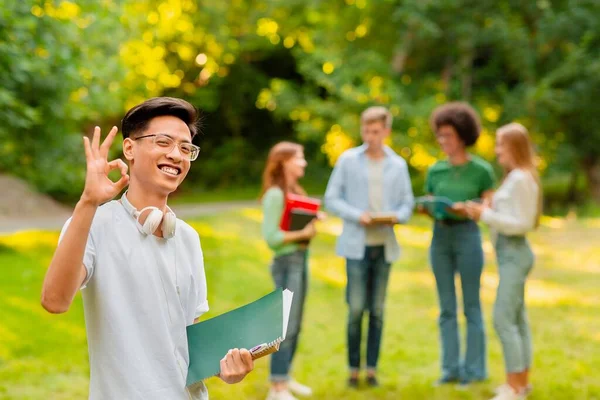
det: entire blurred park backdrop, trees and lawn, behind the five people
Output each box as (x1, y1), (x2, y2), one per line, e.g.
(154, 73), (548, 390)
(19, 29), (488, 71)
(0, 0), (600, 400)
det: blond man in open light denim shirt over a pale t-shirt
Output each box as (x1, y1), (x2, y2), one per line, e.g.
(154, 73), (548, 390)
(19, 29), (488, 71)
(325, 107), (414, 387)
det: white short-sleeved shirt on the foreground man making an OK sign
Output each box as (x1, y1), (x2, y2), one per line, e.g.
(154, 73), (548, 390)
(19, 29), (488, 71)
(61, 201), (208, 400)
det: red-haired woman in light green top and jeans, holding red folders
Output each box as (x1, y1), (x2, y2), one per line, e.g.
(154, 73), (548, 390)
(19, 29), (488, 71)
(262, 142), (316, 400)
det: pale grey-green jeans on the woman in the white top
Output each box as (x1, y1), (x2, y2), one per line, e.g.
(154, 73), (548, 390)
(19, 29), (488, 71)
(494, 235), (534, 373)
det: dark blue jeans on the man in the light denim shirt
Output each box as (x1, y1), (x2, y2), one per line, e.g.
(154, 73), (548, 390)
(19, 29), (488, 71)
(346, 246), (390, 371)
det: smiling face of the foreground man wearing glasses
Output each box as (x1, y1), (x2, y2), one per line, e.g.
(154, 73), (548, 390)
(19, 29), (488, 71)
(123, 116), (192, 196)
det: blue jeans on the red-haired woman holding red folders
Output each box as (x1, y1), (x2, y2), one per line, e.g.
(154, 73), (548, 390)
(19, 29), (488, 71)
(271, 250), (308, 382)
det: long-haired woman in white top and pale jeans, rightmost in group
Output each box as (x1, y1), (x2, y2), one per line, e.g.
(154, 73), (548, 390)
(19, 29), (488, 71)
(466, 123), (542, 400)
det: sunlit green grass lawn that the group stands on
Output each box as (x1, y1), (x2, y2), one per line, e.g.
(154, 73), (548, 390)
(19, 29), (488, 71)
(0, 209), (600, 400)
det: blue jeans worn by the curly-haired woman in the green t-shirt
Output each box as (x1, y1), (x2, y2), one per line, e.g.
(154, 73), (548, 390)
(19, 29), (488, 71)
(430, 221), (487, 381)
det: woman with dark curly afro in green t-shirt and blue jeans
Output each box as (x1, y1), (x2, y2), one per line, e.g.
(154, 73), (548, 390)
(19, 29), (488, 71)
(426, 102), (495, 385)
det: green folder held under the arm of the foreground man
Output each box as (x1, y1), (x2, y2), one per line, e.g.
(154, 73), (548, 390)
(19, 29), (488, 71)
(186, 288), (293, 386)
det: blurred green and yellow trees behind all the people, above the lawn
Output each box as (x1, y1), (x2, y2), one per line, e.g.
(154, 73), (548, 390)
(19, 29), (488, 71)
(0, 0), (600, 214)
